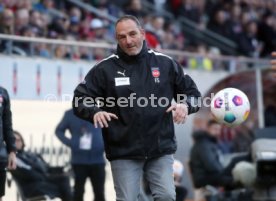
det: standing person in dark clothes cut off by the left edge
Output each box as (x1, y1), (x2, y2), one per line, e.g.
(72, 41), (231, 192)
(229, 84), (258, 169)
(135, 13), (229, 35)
(0, 87), (16, 201)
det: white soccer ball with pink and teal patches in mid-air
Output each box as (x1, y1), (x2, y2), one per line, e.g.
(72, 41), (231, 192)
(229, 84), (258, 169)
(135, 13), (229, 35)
(211, 88), (250, 126)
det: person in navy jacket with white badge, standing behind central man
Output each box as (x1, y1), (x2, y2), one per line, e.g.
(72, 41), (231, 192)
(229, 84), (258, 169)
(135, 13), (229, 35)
(56, 109), (105, 201)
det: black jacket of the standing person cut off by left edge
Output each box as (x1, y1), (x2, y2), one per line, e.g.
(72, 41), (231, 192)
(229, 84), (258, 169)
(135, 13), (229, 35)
(0, 87), (16, 160)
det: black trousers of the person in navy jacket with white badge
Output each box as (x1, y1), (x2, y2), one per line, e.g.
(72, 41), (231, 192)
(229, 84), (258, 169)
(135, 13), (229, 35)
(72, 164), (105, 201)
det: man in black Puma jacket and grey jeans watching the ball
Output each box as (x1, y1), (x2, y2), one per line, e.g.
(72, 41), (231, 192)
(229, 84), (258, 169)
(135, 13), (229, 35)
(73, 15), (200, 201)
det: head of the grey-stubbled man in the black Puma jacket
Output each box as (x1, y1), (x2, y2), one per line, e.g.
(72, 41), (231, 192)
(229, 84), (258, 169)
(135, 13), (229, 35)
(116, 20), (145, 56)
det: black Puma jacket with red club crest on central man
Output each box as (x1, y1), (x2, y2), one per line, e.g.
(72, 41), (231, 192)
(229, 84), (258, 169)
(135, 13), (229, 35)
(73, 43), (201, 160)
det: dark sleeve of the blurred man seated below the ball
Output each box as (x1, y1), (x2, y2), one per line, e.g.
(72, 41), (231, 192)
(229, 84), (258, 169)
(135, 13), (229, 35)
(198, 143), (223, 173)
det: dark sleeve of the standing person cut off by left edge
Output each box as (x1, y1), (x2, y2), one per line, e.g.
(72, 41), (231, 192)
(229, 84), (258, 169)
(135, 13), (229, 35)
(2, 90), (16, 153)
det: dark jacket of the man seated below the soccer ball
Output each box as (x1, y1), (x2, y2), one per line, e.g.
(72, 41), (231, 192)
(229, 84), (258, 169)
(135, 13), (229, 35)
(189, 131), (232, 188)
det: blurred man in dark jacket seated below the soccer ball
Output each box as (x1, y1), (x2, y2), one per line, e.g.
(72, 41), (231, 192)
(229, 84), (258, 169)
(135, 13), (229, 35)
(189, 120), (250, 190)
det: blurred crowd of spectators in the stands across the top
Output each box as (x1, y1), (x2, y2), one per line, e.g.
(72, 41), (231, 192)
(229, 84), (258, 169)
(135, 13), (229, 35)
(0, 0), (276, 61)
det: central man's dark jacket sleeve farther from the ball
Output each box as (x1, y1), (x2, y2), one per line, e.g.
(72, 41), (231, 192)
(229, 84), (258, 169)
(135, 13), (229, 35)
(72, 66), (105, 122)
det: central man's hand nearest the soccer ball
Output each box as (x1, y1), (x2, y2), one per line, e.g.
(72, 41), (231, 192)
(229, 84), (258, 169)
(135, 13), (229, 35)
(166, 103), (188, 124)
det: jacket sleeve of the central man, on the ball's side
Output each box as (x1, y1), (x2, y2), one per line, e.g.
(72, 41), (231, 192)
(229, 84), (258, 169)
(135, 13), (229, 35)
(173, 61), (201, 114)
